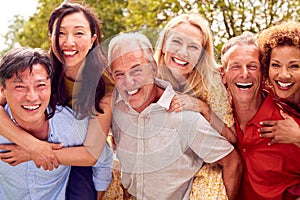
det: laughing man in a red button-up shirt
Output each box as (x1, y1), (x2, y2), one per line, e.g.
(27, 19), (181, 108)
(222, 33), (300, 200)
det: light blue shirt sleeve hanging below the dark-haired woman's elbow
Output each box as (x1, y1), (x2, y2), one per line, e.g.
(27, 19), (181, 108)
(93, 144), (113, 191)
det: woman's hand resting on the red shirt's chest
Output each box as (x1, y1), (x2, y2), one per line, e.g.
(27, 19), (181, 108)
(258, 111), (300, 147)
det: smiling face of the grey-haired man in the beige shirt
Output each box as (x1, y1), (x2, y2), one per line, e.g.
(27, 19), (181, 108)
(111, 50), (156, 112)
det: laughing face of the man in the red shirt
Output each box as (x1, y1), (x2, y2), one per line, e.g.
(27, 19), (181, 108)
(223, 45), (262, 104)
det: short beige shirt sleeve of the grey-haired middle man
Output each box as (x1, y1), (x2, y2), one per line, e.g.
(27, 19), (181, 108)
(189, 116), (234, 163)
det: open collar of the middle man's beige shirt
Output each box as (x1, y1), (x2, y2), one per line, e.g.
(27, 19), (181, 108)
(113, 78), (176, 109)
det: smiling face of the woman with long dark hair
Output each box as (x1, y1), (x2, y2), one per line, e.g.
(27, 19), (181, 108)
(51, 12), (97, 79)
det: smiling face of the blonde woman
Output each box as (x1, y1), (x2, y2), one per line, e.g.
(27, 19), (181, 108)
(162, 22), (203, 78)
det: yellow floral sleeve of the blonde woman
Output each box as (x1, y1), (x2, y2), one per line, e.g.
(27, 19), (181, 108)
(207, 75), (234, 127)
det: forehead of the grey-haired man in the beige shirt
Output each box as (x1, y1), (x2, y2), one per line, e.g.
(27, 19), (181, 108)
(111, 49), (149, 71)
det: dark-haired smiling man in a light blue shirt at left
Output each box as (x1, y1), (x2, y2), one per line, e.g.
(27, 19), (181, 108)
(0, 47), (111, 200)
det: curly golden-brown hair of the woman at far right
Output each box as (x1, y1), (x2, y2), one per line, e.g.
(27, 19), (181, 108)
(257, 21), (300, 77)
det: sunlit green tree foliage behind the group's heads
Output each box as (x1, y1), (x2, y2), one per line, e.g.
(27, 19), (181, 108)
(2, 0), (300, 58)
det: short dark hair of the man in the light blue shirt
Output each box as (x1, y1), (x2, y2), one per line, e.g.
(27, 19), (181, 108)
(0, 47), (57, 119)
